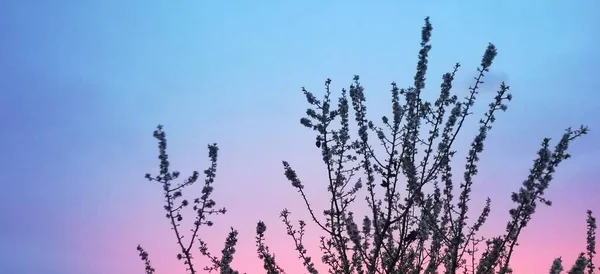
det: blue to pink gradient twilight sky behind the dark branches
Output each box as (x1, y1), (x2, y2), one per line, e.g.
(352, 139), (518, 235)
(0, 0), (600, 274)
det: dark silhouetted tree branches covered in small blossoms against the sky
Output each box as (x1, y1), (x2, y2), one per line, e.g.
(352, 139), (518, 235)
(138, 18), (596, 274)
